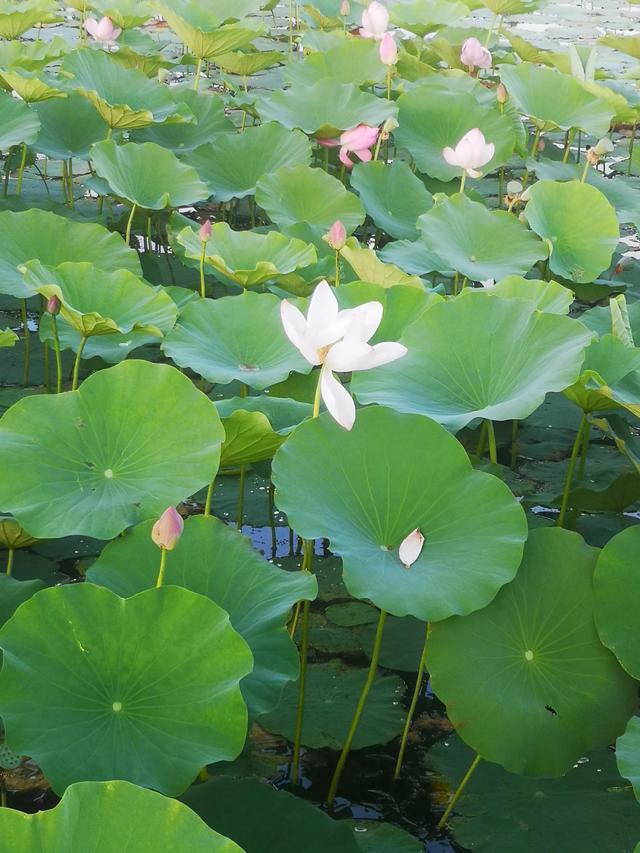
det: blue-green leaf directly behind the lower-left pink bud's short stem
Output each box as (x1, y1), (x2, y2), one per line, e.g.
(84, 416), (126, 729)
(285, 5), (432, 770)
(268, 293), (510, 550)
(87, 515), (317, 715)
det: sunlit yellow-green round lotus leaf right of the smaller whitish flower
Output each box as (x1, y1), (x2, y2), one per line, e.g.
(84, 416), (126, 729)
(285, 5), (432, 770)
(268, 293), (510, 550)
(525, 181), (620, 284)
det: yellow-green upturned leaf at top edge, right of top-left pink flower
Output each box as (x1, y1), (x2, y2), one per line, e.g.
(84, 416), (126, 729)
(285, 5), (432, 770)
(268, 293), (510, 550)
(156, 3), (261, 60)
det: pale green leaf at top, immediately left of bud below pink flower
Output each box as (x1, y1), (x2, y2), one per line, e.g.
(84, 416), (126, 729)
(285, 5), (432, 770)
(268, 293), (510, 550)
(283, 38), (387, 86)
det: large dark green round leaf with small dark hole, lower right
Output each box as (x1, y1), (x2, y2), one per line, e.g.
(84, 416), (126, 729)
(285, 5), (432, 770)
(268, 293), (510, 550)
(427, 527), (637, 776)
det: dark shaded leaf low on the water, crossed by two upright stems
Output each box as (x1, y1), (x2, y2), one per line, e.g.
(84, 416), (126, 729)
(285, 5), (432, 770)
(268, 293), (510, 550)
(258, 656), (405, 749)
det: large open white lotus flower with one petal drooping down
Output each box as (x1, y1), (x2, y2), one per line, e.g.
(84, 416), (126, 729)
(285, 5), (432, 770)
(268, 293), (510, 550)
(280, 281), (407, 429)
